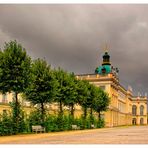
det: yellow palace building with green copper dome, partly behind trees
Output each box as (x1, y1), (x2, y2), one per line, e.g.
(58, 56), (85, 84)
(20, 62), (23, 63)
(0, 51), (147, 127)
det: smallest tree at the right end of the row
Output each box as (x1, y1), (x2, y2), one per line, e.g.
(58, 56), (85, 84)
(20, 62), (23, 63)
(92, 88), (110, 120)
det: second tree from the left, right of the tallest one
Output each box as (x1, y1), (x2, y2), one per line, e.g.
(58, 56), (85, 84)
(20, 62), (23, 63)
(25, 59), (57, 123)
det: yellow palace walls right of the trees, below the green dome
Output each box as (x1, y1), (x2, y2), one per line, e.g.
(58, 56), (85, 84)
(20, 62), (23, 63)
(77, 73), (147, 127)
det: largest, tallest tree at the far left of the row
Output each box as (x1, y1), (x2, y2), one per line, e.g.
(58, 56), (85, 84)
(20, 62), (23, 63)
(0, 40), (31, 131)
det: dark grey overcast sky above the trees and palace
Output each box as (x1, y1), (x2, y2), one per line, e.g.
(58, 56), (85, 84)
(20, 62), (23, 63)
(0, 4), (148, 95)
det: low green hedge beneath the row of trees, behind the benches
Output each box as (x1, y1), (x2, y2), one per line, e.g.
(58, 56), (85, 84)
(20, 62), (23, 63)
(0, 110), (104, 136)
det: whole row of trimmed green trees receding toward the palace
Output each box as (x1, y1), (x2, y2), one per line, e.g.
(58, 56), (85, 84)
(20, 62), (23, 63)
(0, 41), (109, 134)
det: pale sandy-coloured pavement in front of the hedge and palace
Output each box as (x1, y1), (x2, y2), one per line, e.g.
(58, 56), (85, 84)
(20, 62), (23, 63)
(0, 126), (148, 144)
